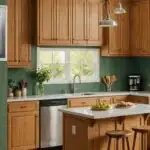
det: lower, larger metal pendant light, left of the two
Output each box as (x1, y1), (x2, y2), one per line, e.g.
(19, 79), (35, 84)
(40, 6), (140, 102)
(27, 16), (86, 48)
(99, 0), (118, 27)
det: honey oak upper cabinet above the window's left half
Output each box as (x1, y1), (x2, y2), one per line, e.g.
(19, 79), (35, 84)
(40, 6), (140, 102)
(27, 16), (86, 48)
(36, 0), (72, 45)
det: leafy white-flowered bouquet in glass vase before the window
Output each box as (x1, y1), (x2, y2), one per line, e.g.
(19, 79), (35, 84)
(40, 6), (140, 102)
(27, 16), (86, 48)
(34, 67), (52, 95)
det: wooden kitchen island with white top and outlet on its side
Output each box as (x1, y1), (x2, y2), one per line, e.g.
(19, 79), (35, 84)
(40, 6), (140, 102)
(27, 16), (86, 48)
(60, 104), (150, 150)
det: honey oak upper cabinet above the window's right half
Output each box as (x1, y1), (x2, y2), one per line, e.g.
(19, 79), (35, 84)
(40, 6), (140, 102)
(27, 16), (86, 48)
(73, 0), (102, 46)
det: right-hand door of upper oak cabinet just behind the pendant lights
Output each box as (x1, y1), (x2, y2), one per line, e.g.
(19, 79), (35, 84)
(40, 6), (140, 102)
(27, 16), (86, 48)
(120, 2), (130, 55)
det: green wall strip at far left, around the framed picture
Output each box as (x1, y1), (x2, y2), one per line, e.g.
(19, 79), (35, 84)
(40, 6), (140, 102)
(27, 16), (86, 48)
(0, 0), (7, 150)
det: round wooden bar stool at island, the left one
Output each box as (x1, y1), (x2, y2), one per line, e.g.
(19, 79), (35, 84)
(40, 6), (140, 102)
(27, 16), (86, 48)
(106, 130), (132, 150)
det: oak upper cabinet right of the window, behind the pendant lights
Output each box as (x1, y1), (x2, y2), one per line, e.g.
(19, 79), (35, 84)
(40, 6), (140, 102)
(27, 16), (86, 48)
(101, 1), (130, 56)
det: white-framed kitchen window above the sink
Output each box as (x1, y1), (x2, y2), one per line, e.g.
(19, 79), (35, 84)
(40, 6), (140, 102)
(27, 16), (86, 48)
(37, 48), (100, 84)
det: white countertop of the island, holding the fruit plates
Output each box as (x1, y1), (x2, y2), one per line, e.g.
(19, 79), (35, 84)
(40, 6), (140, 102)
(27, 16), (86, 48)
(60, 104), (150, 119)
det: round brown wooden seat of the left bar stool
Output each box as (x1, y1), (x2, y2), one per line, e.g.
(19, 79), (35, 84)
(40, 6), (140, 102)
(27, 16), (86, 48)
(106, 130), (132, 138)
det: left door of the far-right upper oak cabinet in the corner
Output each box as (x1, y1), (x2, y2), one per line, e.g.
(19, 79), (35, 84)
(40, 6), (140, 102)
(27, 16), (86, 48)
(130, 3), (140, 55)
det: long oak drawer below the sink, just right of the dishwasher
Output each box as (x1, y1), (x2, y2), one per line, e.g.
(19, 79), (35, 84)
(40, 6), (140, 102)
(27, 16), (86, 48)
(68, 97), (99, 107)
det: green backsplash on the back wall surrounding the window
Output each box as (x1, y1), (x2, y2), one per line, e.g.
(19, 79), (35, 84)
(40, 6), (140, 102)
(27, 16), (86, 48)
(8, 47), (133, 95)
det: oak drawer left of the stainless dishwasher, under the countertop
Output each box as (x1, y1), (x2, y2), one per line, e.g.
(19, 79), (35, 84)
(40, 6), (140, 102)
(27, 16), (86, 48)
(8, 102), (39, 112)
